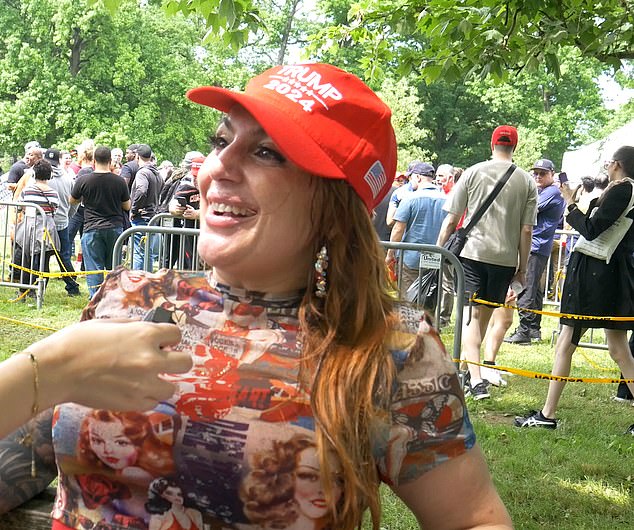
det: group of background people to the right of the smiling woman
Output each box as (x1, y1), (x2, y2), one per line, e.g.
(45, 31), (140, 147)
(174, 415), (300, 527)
(374, 125), (634, 429)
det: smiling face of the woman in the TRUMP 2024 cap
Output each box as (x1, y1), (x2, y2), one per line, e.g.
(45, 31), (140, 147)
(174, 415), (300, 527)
(198, 106), (314, 292)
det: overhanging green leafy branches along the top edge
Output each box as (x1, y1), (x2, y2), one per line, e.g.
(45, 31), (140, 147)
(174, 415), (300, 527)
(91, 0), (634, 81)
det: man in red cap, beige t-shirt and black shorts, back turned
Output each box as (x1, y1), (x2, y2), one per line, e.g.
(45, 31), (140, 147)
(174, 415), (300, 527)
(437, 125), (537, 400)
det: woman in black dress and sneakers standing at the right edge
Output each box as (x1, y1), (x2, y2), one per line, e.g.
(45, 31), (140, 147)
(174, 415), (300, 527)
(515, 146), (634, 429)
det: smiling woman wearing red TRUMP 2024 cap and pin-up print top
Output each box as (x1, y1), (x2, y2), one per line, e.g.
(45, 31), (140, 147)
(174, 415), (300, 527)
(0, 64), (511, 530)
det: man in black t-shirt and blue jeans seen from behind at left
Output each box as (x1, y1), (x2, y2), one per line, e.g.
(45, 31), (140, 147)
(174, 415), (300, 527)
(70, 146), (130, 298)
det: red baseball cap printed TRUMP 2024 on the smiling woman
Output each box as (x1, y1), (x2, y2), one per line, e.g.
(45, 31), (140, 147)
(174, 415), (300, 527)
(187, 63), (396, 210)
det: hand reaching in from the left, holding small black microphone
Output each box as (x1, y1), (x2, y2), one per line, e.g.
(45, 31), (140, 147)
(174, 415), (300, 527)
(28, 320), (192, 410)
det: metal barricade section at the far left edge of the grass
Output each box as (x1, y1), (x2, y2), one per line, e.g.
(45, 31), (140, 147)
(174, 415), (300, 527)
(0, 201), (47, 309)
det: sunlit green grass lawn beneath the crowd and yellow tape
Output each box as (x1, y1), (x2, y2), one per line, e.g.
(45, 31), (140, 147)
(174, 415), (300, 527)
(0, 280), (634, 530)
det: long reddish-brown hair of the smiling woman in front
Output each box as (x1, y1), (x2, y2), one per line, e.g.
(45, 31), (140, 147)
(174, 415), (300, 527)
(299, 178), (394, 530)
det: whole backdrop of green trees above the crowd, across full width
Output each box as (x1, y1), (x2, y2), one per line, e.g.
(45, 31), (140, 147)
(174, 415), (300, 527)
(0, 0), (634, 172)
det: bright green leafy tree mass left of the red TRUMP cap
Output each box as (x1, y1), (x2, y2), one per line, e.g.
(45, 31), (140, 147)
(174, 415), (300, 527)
(0, 0), (251, 159)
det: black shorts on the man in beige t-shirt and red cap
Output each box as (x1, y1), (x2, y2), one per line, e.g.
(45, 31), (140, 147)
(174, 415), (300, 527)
(460, 258), (516, 304)
